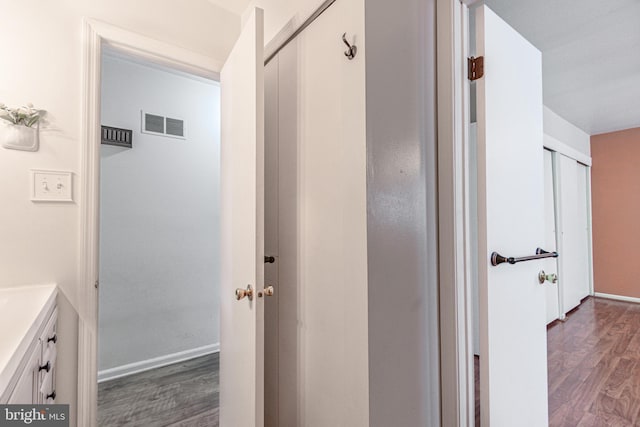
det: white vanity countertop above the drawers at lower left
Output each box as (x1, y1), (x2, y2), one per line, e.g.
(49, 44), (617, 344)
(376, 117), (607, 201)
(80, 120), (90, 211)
(0, 284), (58, 397)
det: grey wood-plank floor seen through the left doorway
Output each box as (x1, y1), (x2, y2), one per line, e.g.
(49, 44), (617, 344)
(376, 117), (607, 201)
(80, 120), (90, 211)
(98, 353), (219, 427)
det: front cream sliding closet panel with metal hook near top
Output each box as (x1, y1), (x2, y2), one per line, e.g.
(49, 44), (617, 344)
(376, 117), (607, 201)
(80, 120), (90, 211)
(294, 1), (369, 427)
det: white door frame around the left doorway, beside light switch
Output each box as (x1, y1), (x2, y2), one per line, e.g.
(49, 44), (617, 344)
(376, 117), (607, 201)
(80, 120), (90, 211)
(76, 18), (224, 427)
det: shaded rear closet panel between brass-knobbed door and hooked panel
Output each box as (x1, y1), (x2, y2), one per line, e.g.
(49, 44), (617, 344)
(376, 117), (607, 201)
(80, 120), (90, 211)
(265, 38), (304, 426)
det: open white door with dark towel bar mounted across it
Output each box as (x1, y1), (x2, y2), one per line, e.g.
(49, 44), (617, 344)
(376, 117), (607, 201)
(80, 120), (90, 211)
(476, 6), (548, 427)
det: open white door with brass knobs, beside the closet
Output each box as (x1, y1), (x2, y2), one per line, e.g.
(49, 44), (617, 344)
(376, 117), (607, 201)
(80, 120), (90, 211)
(220, 9), (264, 427)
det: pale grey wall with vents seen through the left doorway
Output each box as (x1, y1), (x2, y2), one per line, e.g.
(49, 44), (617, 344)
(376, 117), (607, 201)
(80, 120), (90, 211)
(98, 55), (220, 378)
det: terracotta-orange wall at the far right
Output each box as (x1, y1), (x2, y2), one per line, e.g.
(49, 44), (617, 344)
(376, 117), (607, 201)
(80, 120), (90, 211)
(591, 128), (640, 298)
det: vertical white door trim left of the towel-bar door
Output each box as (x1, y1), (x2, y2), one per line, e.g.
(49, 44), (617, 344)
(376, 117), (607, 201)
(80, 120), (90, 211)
(437, 0), (475, 427)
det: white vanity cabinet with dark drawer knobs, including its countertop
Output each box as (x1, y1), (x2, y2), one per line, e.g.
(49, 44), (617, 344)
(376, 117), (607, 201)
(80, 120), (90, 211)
(0, 286), (58, 404)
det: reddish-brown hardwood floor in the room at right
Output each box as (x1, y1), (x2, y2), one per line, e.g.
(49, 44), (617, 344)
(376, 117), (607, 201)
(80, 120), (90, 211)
(474, 297), (640, 427)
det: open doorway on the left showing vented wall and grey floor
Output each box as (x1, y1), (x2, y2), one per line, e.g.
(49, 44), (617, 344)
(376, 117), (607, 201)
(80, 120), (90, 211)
(98, 48), (220, 426)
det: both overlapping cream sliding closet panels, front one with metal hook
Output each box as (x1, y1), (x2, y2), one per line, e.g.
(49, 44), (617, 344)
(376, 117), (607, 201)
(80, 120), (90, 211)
(265, 1), (369, 427)
